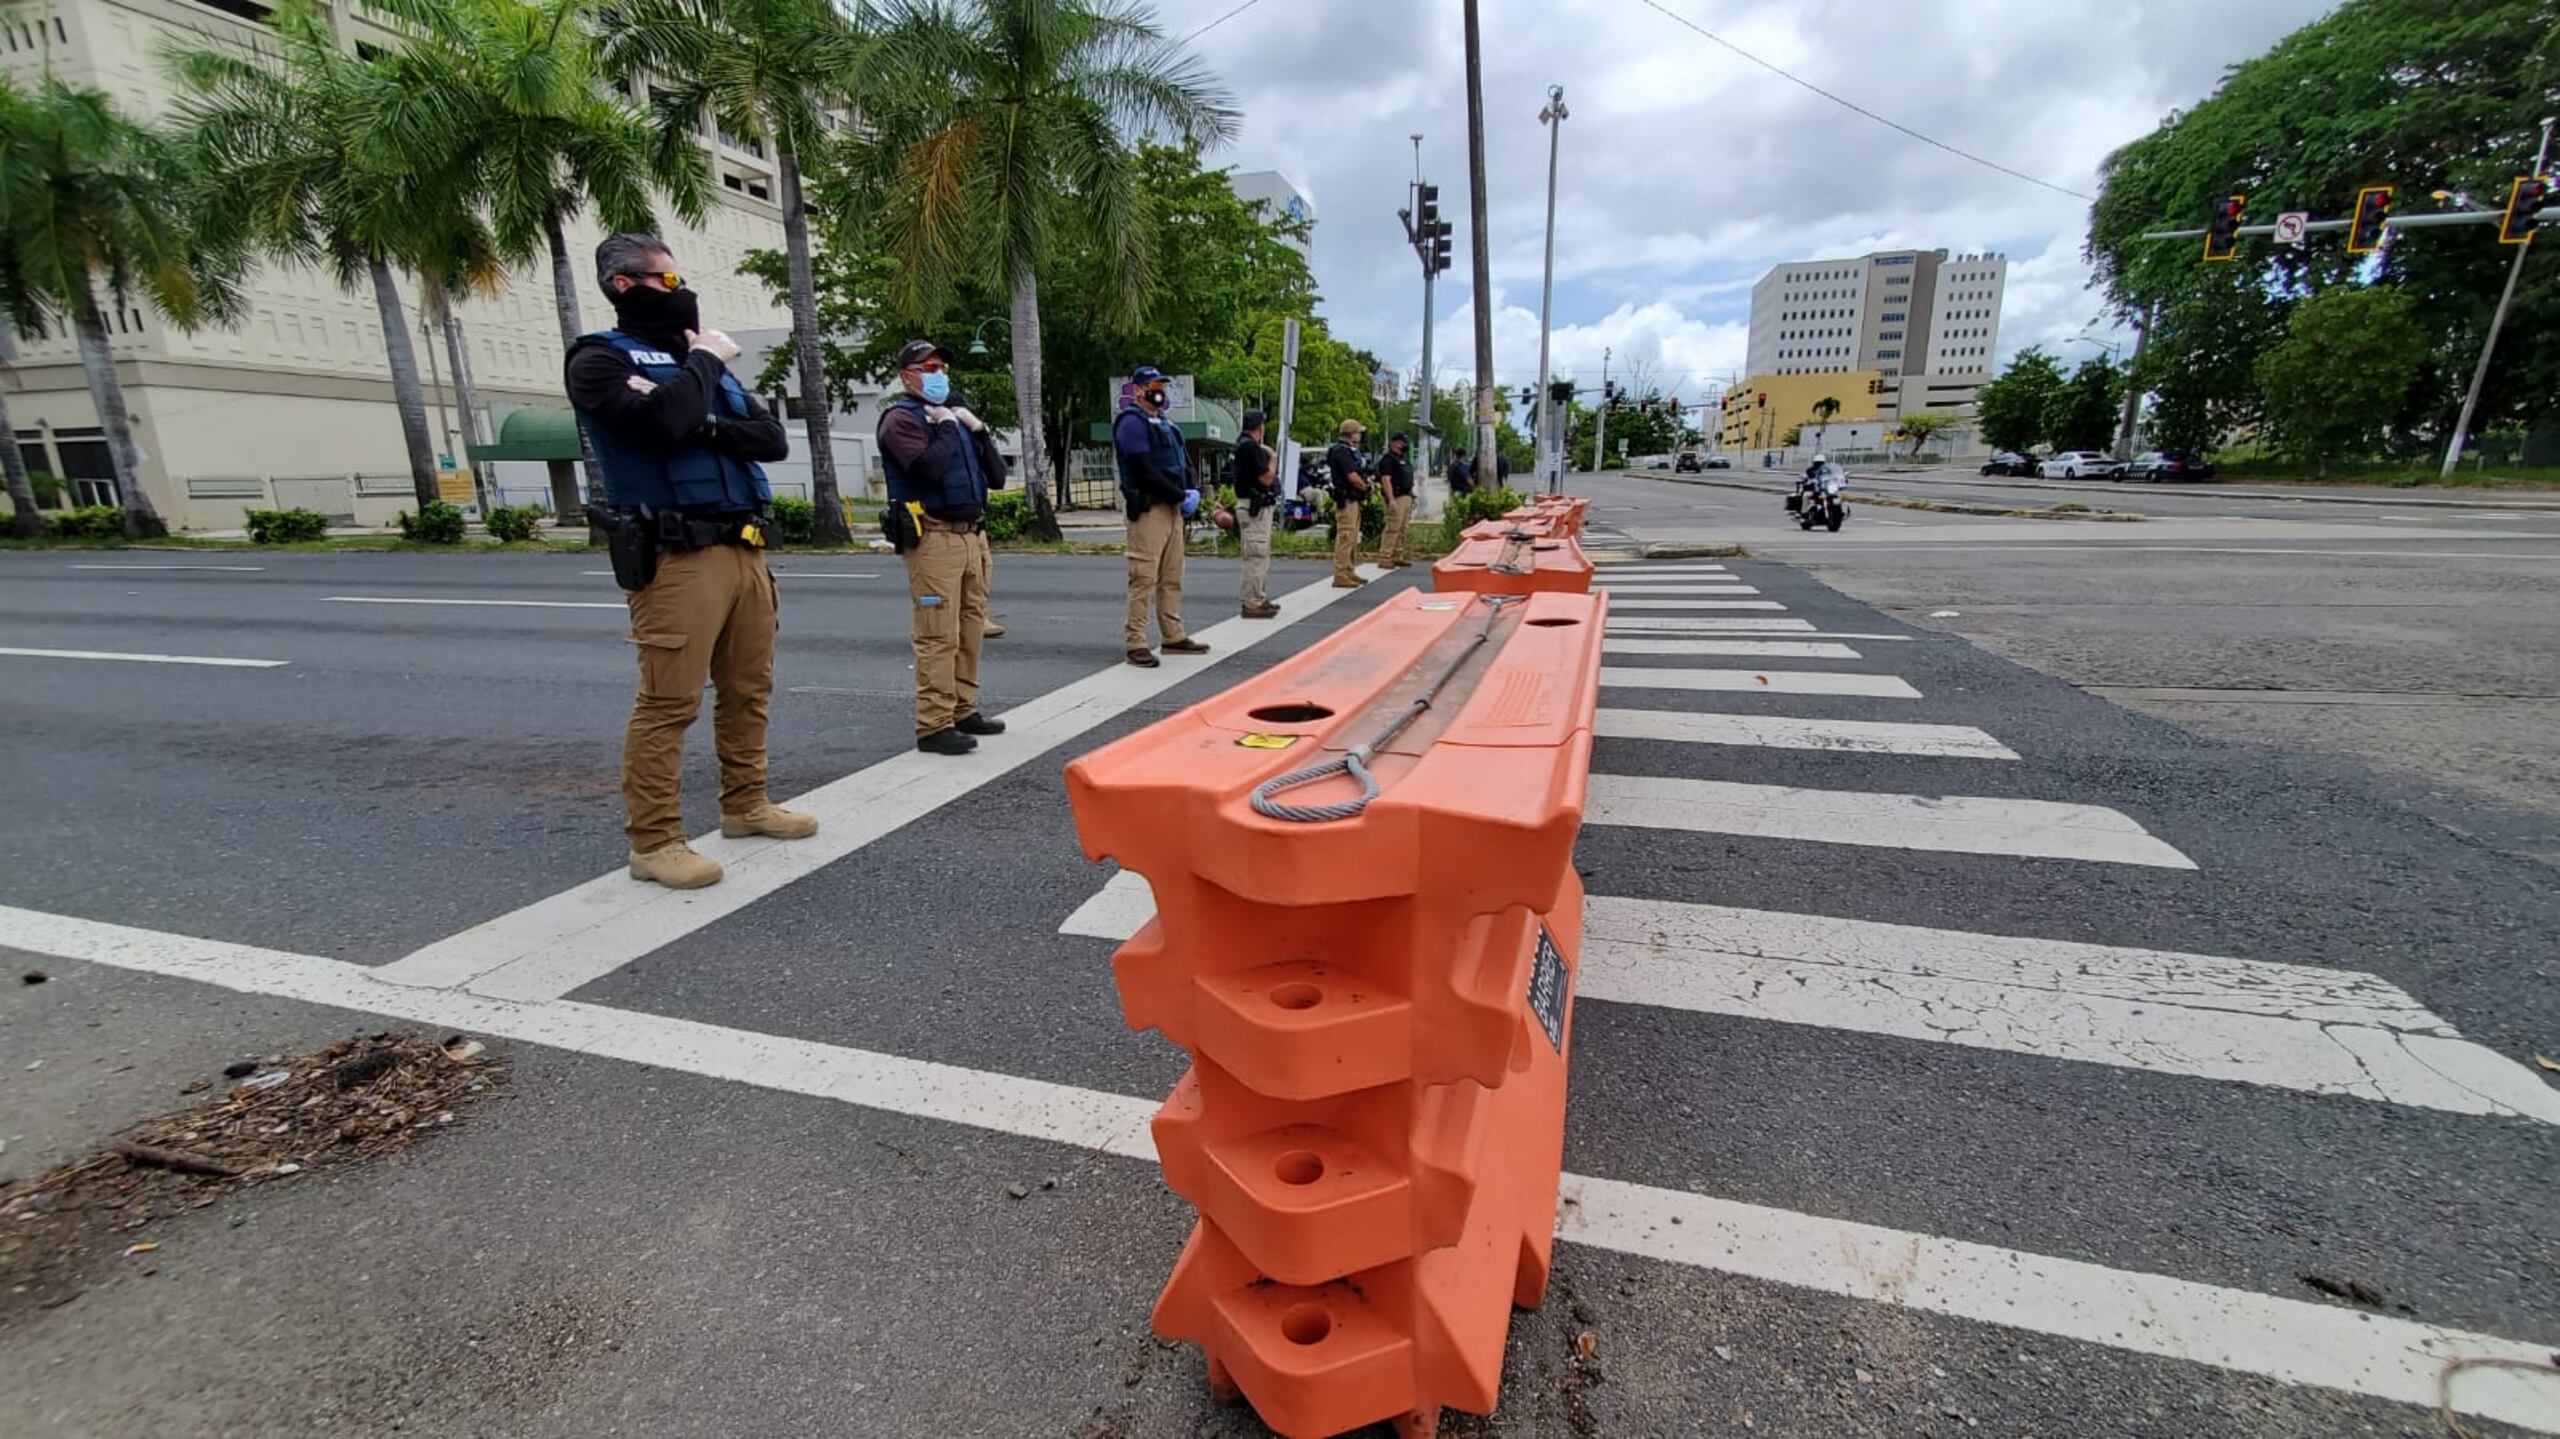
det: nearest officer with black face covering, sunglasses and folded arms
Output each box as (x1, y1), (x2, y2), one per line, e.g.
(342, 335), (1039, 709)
(566, 236), (817, 888)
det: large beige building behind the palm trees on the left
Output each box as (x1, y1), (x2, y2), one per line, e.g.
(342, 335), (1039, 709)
(0, 0), (788, 530)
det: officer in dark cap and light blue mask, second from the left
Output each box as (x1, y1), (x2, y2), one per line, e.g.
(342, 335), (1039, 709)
(878, 341), (1006, 755)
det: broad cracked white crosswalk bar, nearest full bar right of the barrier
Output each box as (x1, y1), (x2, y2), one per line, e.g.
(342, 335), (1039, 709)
(1577, 896), (2560, 1124)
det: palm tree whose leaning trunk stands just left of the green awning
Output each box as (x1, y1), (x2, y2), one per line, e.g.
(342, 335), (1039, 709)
(172, 0), (453, 510)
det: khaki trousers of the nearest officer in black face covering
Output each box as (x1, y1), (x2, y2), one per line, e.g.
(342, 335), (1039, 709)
(622, 545), (778, 853)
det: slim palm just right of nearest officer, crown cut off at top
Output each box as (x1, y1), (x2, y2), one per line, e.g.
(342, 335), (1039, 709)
(602, 0), (870, 543)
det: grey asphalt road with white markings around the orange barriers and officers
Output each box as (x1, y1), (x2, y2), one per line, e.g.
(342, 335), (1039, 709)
(0, 540), (2560, 1439)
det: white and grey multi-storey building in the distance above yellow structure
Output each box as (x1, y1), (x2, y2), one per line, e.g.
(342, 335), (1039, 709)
(1748, 251), (2010, 415)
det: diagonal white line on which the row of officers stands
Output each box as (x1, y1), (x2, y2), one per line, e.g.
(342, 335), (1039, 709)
(381, 568), (1377, 999)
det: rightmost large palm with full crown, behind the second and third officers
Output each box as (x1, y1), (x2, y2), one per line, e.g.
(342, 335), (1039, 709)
(865, 0), (1236, 533)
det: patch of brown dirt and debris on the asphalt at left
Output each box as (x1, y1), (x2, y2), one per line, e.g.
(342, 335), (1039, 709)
(0, 1029), (504, 1326)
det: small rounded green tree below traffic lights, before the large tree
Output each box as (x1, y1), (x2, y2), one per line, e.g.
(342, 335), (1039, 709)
(2258, 287), (2427, 474)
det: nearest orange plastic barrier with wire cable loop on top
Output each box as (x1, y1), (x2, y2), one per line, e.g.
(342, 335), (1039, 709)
(1068, 591), (1608, 1439)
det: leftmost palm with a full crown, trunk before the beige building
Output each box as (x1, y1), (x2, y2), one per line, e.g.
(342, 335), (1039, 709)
(0, 74), (238, 538)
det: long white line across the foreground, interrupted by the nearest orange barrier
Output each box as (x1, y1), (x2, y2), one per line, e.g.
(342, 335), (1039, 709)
(0, 906), (2555, 1431)
